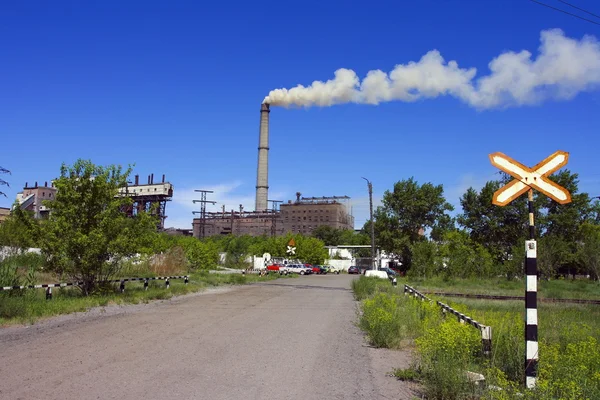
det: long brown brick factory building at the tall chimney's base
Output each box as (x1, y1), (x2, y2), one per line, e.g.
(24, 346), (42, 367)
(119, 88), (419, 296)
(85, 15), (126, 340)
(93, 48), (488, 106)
(192, 194), (354, 238)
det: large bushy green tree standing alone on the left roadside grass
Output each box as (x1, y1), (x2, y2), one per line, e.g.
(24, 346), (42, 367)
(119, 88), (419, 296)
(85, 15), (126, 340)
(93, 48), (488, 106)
(41, 160), (156, 295)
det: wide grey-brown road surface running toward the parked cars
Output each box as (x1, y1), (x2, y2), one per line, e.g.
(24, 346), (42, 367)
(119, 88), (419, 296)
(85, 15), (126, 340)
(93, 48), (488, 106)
(0, 275), (414, 400)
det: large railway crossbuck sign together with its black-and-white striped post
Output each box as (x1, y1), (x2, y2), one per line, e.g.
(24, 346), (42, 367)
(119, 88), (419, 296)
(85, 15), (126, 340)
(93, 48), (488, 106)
(490, 151), (571, 389)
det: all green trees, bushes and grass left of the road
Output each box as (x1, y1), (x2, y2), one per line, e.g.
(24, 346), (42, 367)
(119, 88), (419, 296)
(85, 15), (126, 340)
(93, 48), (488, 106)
(0, 160), (314, 325)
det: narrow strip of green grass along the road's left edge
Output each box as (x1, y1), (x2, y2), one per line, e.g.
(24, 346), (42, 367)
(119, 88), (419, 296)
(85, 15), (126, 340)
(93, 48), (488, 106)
(0, 271), (290, 326)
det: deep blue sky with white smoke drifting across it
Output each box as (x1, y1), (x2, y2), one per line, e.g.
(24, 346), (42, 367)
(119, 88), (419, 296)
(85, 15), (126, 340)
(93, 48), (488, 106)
(0, 0), (600, 228)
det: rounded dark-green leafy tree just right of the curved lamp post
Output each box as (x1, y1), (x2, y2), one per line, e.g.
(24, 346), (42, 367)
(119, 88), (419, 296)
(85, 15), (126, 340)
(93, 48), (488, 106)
(374, 178), (454, 269)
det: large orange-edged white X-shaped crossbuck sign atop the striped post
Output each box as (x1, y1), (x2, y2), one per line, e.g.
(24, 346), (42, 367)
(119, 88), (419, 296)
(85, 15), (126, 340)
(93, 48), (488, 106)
(490, 151), (571, 206)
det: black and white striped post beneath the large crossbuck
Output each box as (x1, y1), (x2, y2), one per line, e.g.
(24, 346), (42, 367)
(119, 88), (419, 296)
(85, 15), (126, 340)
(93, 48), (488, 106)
(525, 189), (538, 389)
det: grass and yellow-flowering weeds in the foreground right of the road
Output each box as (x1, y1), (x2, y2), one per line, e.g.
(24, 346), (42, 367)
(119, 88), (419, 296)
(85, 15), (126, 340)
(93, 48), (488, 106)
(353, 277), (600, 400)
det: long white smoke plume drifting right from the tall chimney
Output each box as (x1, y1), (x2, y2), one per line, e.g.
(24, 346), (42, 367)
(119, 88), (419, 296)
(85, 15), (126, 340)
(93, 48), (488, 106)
(263, 29), (600, 109)
